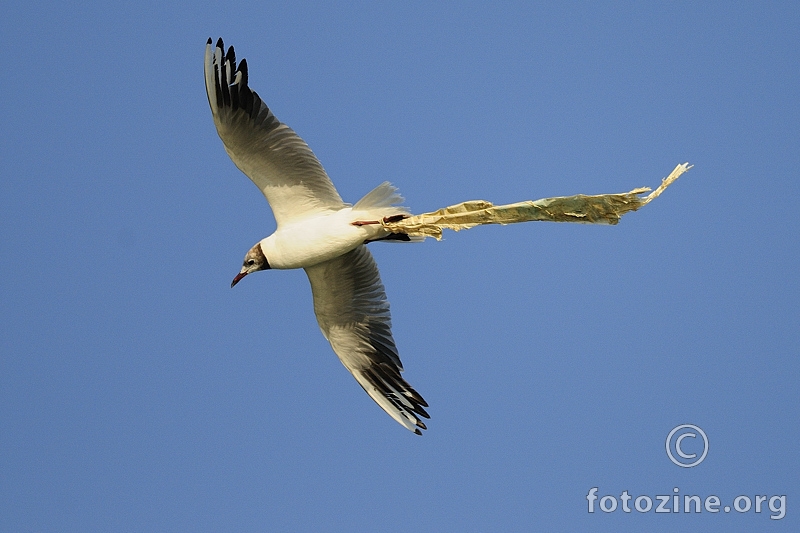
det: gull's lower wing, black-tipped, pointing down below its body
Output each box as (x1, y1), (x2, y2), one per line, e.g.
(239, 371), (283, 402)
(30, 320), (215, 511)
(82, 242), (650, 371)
(305, 245), (429, 435)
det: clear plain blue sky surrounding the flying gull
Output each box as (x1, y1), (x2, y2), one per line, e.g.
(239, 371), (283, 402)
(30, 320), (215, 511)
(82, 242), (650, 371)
(0, 0), (800, 532)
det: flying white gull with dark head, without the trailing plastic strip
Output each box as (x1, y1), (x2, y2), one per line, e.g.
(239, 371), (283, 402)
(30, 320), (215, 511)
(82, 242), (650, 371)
(205, 38), (430, 435)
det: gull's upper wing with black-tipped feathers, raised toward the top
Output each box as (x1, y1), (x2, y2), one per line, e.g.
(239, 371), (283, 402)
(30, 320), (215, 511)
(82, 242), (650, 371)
(205, 39), (345, 225)
